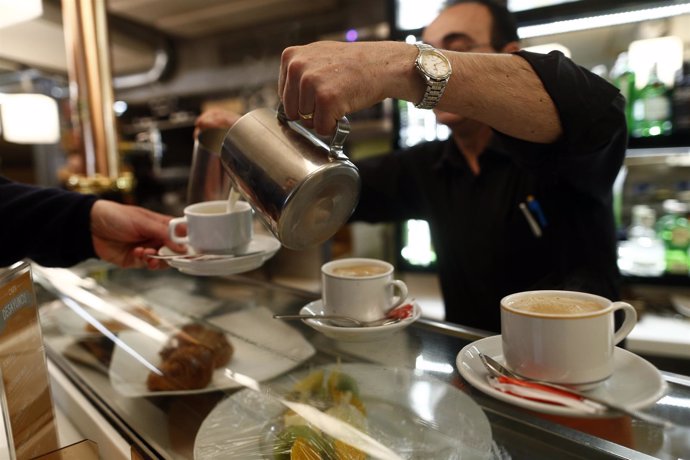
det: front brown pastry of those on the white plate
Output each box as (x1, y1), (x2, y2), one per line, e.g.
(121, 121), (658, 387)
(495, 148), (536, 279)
(146, 346), (213, 391)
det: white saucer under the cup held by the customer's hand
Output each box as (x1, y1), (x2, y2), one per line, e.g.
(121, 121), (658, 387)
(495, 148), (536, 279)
(158, 235), (280, 276)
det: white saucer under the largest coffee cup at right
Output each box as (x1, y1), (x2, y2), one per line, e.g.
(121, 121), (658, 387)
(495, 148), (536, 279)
(455, 335), (667, 417)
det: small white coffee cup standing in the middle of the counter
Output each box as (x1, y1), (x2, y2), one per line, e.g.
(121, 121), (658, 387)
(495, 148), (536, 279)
(321, 258), (407, 321)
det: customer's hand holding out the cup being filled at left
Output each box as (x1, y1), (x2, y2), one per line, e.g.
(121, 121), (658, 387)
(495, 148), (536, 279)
(91, 200), (185, 269)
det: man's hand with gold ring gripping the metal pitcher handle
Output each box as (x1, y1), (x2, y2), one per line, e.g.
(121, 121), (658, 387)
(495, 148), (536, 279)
(278, 41), (424, 135)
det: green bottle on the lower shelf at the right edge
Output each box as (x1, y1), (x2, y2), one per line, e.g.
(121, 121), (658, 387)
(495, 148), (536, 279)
(657, 199), (690, 275)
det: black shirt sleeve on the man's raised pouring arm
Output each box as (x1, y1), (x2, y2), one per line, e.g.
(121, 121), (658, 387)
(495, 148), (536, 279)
(497, 51), (627, 197)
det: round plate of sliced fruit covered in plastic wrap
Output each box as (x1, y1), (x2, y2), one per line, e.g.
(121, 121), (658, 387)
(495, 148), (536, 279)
(194, 363), (493, 460)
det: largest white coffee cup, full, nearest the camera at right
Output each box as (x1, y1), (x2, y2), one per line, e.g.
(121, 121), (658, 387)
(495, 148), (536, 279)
(501, 291), (637, 389)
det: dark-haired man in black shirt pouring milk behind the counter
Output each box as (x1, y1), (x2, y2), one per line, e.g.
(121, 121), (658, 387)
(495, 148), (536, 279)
(280, 0), (627, 332)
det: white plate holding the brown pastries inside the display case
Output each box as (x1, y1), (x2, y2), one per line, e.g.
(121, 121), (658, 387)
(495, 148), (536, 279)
(109, 307), (316, 397)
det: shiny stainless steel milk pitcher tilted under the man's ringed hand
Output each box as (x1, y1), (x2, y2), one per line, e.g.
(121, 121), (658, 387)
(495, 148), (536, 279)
(221, 105), (361, 250)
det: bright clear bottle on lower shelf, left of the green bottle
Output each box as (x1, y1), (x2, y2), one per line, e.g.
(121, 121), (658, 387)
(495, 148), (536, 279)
(618, 204), (666, 276)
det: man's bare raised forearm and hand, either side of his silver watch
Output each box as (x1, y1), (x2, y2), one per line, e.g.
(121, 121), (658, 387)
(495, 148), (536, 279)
(279, 42), (562, 143)
